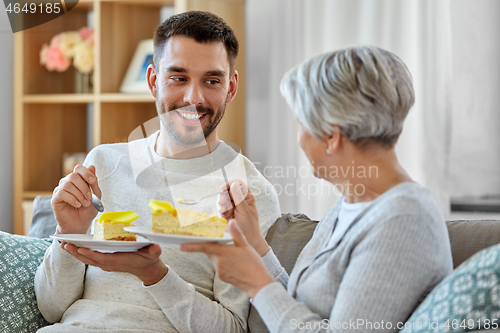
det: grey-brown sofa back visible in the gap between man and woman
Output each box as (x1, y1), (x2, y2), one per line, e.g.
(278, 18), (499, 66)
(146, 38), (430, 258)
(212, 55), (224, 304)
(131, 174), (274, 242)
(248, 213), (318, 333)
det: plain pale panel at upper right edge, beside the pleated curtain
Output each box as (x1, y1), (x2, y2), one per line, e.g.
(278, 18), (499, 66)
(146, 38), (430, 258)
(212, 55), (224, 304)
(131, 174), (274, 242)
(450, 0), (500, 197)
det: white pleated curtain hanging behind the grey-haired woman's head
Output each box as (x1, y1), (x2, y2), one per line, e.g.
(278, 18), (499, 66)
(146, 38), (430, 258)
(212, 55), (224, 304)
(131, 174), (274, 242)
(247, 0), (452, 219)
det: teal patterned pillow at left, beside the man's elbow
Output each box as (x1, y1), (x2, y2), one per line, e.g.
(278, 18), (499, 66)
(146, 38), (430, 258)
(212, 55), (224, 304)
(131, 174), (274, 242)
(0, 231), (52, 333)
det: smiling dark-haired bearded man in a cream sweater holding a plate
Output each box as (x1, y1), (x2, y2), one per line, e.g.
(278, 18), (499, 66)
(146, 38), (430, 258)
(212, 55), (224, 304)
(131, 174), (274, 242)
(35, 12), (280, 333)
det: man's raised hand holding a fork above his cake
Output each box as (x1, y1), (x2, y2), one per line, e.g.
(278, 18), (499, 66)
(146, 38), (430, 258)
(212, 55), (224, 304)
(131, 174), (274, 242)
(51, 165), (102, 234)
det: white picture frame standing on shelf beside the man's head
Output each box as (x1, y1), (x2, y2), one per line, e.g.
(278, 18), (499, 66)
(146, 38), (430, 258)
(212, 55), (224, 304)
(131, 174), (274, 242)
(120, 39), (154, 94)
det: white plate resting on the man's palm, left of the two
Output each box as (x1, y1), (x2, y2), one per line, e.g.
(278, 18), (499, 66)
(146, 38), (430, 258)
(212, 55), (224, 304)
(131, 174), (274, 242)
(50, 234), (151, 253)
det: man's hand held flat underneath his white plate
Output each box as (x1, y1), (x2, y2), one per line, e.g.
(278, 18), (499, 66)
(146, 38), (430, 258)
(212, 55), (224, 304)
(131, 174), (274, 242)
(61, 243), (168, 286)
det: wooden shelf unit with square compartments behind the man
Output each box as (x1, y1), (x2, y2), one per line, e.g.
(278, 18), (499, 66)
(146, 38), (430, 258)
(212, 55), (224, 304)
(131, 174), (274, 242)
(14, 0), (245, 234)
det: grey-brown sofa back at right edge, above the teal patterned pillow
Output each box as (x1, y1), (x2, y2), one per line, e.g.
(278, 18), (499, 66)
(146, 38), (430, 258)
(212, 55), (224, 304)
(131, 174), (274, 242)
(446, 220), (500, 267)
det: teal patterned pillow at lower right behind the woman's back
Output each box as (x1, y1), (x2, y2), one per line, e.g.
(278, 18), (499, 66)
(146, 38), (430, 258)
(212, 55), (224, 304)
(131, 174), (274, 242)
(400, 244), (500, 333)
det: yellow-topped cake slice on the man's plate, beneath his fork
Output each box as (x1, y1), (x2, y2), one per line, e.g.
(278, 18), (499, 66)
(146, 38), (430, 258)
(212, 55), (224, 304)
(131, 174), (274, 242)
(92, 210), (139, 241)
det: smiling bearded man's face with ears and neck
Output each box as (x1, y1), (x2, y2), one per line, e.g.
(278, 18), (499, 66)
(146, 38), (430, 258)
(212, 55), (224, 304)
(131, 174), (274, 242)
(152, 26), (238, 156)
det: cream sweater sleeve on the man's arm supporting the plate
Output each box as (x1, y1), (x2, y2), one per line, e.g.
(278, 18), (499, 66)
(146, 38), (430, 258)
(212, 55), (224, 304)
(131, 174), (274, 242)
(145, 267), (250, 333)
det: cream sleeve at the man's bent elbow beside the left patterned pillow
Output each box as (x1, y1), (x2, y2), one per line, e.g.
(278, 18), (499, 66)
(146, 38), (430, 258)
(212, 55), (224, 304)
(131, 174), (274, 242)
(35, 240), (85, 323)
